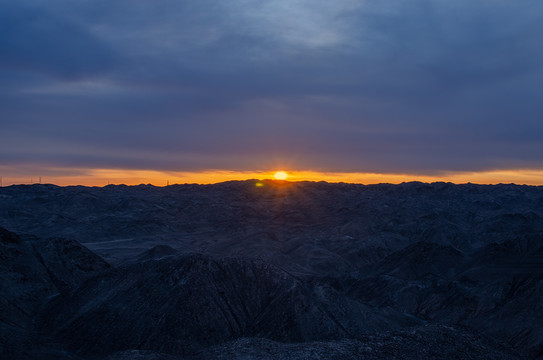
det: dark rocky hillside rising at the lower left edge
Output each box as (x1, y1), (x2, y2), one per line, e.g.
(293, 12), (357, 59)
(0, 228), (109, 359)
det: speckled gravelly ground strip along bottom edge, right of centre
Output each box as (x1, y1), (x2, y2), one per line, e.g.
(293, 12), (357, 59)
(192, 325), (519, 360)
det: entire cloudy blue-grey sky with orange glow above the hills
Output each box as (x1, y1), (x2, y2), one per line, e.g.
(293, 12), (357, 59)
(0, 0), (543, 185)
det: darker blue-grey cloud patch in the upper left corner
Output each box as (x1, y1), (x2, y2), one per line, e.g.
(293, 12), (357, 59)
(0, 2), (114, 78)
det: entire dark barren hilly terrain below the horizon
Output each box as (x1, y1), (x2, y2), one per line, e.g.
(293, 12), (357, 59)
(0, 180), (543, 360)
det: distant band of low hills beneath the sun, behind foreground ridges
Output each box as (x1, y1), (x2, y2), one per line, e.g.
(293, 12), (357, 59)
(0, 180), (543, 274)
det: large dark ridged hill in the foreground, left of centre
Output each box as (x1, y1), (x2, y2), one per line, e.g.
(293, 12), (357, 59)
(39, 255), (422, 355)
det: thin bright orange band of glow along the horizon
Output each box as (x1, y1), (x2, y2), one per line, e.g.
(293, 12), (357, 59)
(0, 169), (543, 186)
